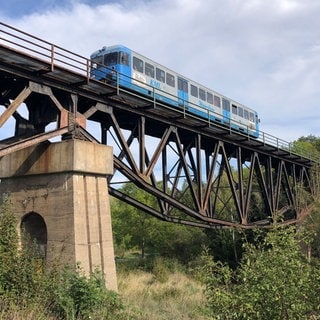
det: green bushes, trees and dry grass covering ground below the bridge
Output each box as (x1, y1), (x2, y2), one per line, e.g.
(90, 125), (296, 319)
(0, 134), (320, 320)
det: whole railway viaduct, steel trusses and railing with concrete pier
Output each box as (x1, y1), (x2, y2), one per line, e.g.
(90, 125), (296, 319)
(0, 23), (317, 290)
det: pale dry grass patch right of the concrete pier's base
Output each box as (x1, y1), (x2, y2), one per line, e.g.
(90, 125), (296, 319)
(118, 271), (208, 320)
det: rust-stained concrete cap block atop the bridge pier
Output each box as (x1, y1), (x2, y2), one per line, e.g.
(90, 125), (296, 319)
(0, 140), (113, 178)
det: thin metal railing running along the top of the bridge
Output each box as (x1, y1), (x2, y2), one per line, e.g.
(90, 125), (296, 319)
(0, 22), (320, 163)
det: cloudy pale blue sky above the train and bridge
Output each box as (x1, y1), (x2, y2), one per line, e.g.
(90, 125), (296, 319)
(0, 0), (320, 142)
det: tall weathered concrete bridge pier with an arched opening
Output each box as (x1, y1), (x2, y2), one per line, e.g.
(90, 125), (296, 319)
(0, 140), (117, 290)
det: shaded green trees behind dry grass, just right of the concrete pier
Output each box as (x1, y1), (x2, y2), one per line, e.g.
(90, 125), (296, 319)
(111, 184), (207, 263)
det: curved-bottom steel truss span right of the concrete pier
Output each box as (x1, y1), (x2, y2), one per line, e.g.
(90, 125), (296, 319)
(103, 108), (311, 228)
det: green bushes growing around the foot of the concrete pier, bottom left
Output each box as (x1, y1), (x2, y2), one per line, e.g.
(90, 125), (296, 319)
(0, 202), (127, 320)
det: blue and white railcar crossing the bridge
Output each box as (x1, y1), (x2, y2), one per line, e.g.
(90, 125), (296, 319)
(90, 45), (259, 138)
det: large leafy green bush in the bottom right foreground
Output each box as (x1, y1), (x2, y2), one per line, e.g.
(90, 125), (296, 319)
(201, 228), (320, 320)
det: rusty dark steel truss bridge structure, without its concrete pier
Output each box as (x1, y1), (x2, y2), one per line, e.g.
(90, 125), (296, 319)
(0, 23), (317, 228)
